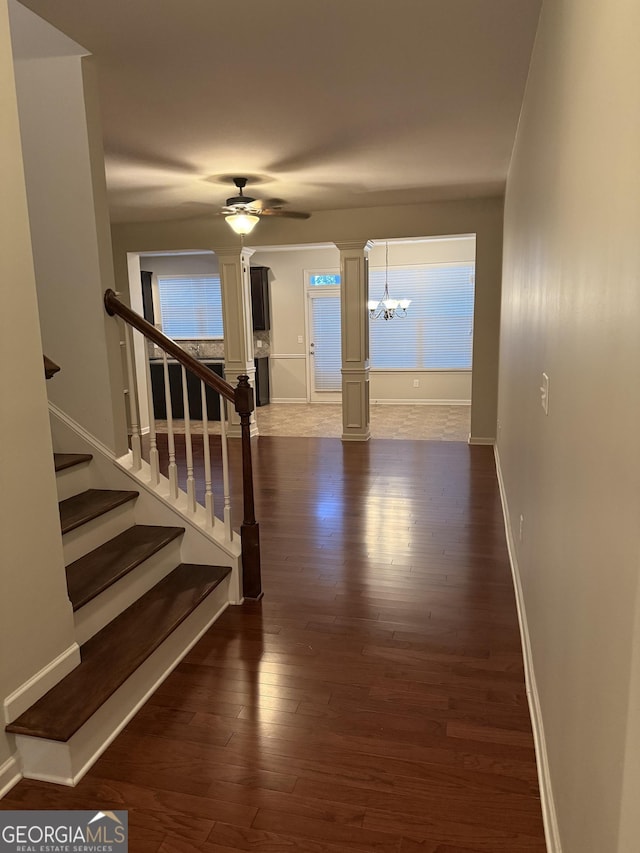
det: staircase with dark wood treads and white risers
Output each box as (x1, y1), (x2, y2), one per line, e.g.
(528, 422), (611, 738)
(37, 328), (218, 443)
(7, 453), (231, 785)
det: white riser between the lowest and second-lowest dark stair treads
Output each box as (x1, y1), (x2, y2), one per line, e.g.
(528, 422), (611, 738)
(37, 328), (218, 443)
(74, 538), (185, 645)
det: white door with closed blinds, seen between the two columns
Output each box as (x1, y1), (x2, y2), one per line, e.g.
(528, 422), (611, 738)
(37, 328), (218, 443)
(307, 287), (342, 403)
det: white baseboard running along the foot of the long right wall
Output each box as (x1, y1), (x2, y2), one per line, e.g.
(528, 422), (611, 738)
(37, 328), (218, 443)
(496, 441), (562, 853)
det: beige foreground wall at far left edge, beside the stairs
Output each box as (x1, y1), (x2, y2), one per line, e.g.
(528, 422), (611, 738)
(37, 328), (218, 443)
(0, 0), (74, 789)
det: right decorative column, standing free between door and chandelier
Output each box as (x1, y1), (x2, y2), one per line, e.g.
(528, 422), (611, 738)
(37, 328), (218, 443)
(336, 240), (373, 441)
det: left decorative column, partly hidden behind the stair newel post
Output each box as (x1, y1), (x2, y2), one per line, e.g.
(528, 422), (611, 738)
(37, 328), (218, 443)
(213, 246), (258, 438)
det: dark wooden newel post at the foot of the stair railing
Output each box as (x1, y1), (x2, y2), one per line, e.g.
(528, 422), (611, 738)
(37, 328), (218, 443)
(235, 375), (263, 599)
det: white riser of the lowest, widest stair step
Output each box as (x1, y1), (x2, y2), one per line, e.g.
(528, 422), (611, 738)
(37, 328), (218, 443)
(16, 578), (229, 785)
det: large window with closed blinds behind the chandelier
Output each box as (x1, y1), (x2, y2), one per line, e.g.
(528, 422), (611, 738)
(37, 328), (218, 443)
(369, 263), (474, 370)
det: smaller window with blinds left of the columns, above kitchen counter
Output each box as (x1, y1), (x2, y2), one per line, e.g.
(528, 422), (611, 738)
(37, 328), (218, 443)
(158, 275), (223, 340)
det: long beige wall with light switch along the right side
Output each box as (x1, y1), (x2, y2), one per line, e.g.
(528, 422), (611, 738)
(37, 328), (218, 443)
(498, 0), (640, 853)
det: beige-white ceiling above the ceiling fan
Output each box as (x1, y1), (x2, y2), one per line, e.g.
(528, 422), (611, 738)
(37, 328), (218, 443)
(15, 0), (541, 222)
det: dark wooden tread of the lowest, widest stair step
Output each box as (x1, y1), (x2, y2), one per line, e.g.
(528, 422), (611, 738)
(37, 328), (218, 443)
(7, 563), (231, 742)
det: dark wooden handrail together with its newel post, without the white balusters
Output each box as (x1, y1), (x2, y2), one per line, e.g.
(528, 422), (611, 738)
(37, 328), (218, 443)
(104, 289), (262, 599)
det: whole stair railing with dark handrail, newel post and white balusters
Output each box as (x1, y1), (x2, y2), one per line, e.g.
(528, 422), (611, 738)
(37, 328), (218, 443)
(104, 289), (262, 598)
